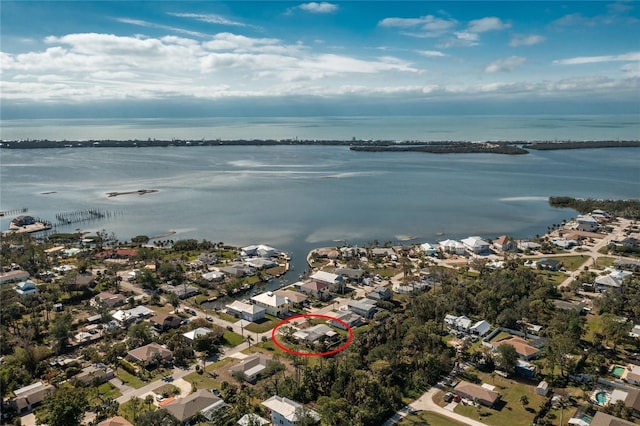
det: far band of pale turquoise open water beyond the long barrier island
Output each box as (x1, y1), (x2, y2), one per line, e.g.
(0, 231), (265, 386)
(0, 114), (640, 141)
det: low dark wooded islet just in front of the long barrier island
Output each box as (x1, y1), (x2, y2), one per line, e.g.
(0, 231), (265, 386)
(350, 142), (528, 155)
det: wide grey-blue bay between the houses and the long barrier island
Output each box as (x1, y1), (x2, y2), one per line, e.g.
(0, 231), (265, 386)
(0, 146), (640, 280)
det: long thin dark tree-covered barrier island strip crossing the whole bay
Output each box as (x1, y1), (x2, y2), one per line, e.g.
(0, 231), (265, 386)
(0, 139), (640, 155)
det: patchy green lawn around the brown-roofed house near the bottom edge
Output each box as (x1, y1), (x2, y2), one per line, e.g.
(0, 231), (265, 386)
(455, 371), (545, 426)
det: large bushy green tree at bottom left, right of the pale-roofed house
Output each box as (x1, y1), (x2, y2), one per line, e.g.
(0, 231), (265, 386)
(36, 388), (89, 426)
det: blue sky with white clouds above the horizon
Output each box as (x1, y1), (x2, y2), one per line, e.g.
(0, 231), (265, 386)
(0, 0), (640, 118)
